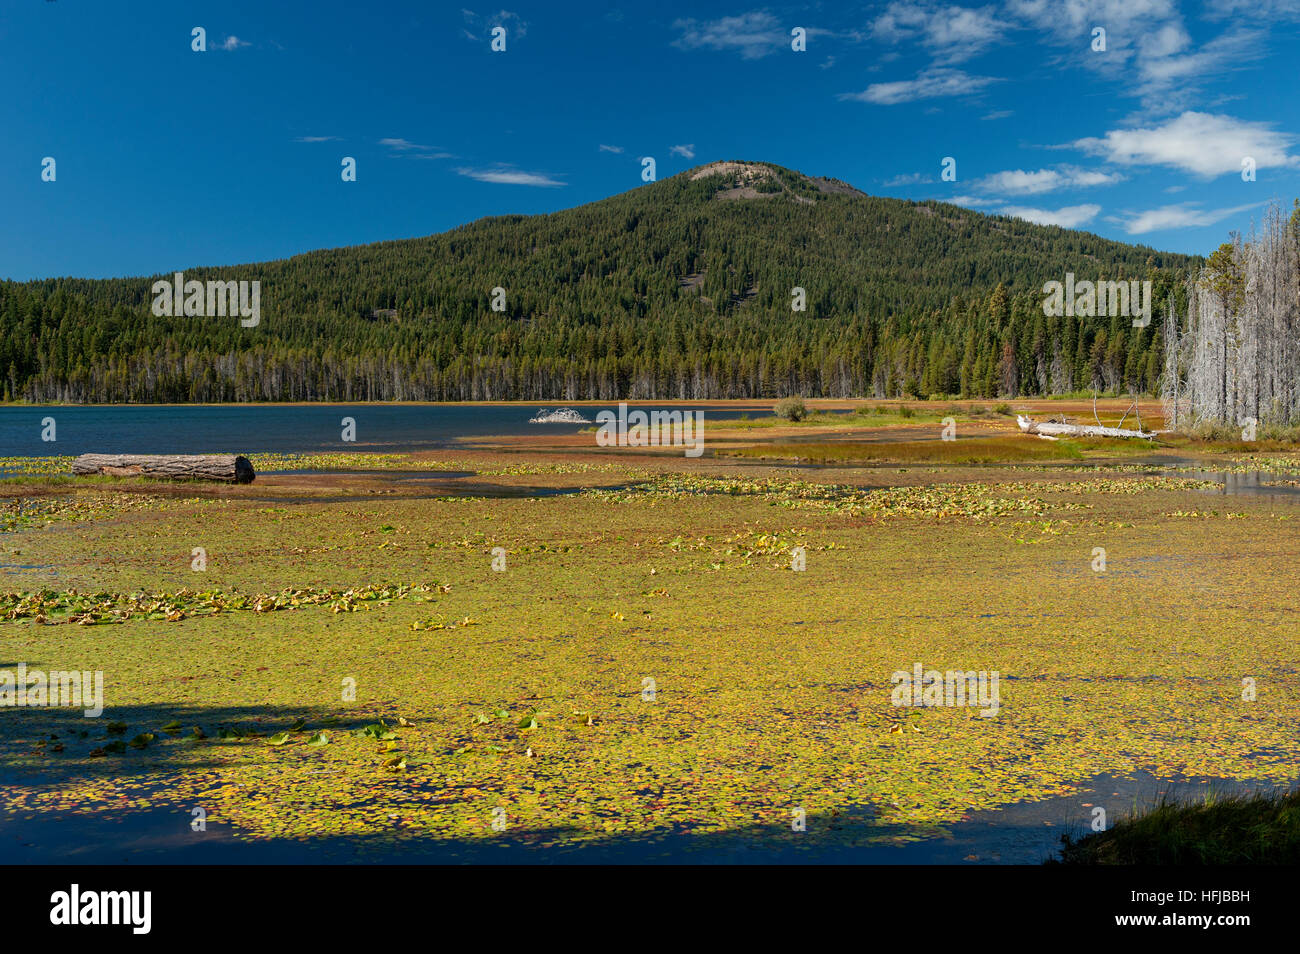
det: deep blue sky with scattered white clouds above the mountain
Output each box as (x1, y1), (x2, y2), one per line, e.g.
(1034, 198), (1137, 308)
(0, 0), (1300, 279)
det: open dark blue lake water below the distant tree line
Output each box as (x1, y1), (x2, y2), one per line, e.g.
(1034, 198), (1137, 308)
(0, 402), (771, 458)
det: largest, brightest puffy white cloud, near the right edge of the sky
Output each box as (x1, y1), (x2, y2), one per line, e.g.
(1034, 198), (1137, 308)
(1074, 112), (1297, 178)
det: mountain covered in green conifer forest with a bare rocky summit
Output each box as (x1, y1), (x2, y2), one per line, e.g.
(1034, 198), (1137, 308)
(0, 162), (1200, 402)
